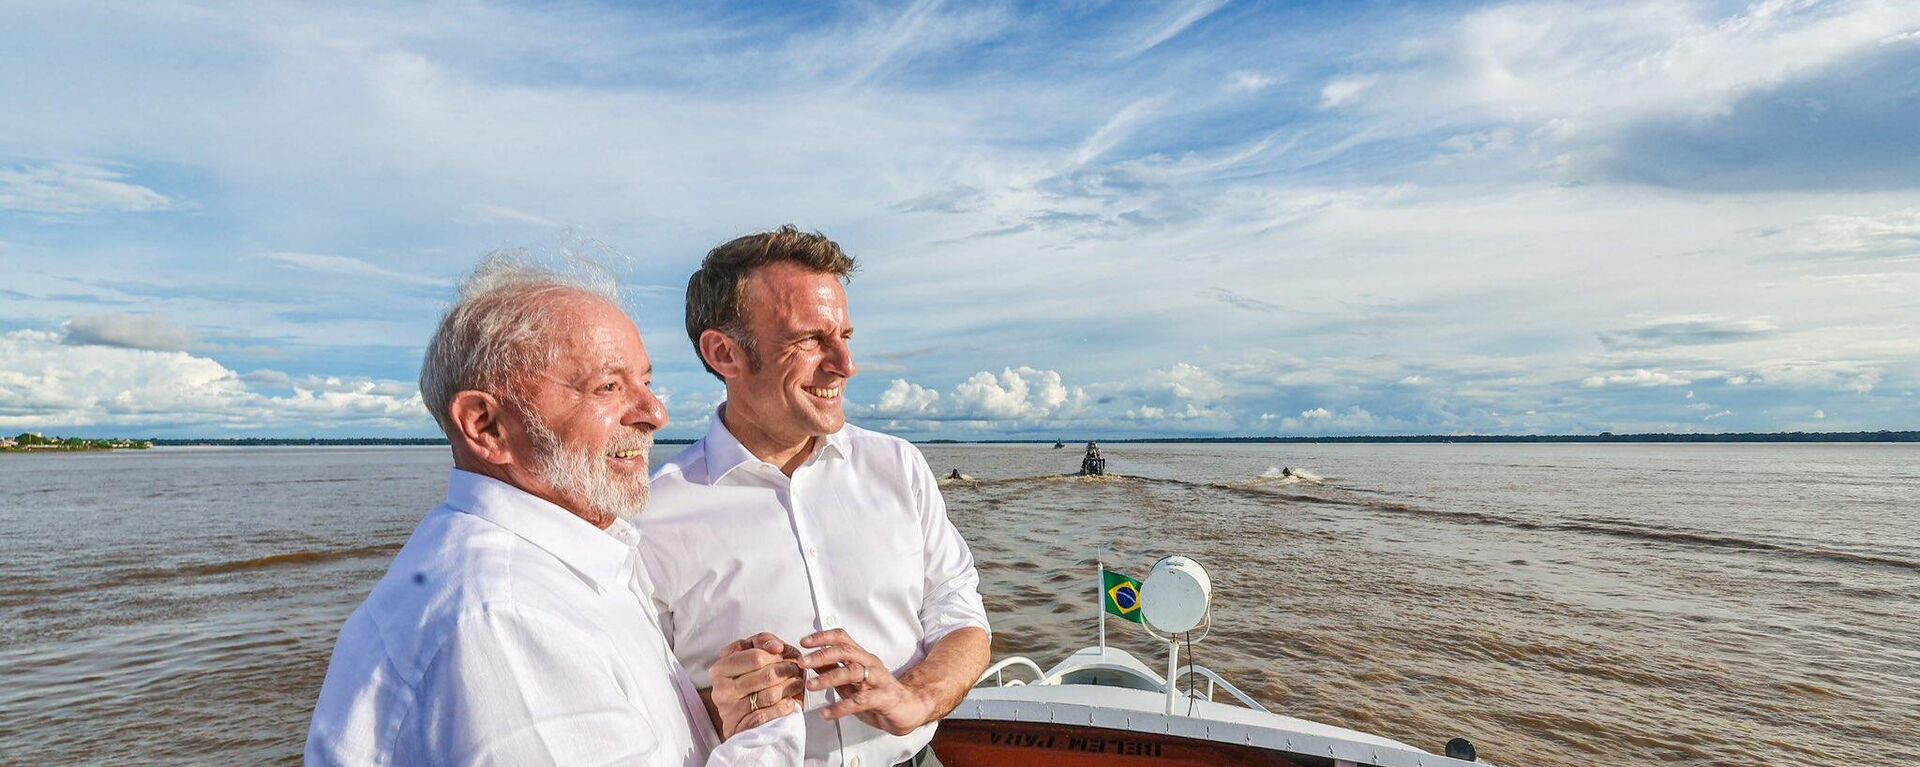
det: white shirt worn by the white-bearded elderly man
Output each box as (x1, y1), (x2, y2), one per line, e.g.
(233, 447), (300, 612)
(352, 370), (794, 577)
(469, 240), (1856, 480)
(307, 469), (804, 767)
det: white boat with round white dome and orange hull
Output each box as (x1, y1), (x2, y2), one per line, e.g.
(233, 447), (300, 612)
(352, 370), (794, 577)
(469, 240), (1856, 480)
(933, 556), (1484, 767)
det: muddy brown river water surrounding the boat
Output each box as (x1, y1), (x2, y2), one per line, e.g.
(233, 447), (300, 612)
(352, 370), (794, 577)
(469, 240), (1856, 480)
(0, 444), (1920, 767)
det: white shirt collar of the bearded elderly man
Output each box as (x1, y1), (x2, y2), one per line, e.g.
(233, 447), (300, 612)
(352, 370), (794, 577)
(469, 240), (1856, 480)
(447, 469), (639, 590)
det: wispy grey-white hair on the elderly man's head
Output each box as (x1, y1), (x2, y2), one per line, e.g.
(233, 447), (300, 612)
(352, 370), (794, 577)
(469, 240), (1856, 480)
(420, 250), (620, 438)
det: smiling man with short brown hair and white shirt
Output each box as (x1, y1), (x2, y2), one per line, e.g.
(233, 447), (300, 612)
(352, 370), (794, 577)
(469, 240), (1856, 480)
(639, 227), (989, 767)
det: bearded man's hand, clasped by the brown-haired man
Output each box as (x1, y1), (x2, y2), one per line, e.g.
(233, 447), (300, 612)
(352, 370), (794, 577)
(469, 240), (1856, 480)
(701, 631), (806, 740)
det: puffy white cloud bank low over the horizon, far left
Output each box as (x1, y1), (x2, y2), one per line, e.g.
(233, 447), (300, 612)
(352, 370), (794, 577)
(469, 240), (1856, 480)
(0, 331), (432, 436)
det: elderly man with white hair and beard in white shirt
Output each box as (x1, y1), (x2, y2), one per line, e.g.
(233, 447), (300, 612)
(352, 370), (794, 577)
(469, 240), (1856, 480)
(305, 254), (804, 767)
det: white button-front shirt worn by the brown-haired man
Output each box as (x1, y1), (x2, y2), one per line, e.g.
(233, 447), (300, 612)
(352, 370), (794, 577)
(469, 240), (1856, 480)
(639, 415), (987, 767)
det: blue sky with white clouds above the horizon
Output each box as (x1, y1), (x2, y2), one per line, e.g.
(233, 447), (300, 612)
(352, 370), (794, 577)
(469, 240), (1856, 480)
(0, 0), (1920, 440)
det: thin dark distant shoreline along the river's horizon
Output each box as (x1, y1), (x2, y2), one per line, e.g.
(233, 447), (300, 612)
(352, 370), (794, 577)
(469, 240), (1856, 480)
(116, 431), (1920, 448)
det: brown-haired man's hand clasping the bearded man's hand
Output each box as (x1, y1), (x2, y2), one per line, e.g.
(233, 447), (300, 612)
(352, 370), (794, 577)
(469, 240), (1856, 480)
(799, 629), (933, 734)
